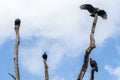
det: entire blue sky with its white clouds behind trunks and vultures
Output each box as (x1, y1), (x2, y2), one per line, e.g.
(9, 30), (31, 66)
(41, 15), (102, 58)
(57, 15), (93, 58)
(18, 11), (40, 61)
(0, 0), (120, 80)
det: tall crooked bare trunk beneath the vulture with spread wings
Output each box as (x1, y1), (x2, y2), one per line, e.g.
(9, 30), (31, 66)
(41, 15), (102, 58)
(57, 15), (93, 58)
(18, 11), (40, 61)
(77, 14), (98, 80)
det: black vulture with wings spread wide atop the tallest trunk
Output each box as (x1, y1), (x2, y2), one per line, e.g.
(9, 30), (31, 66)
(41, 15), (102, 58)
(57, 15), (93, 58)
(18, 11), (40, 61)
(80, 4), (107, 19)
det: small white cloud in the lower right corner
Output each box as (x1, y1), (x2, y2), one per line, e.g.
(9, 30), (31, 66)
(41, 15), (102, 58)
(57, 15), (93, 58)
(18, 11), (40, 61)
(105, 65), (120, 80)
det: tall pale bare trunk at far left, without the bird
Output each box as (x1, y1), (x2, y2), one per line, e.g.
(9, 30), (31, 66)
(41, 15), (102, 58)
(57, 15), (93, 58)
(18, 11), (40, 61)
(14, 25), (20, 80)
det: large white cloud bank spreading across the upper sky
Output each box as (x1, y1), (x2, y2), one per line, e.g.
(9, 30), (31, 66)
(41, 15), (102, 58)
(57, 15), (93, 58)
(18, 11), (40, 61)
(0, 0), (120, 78)
